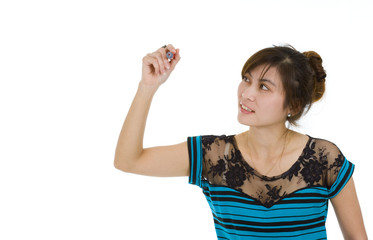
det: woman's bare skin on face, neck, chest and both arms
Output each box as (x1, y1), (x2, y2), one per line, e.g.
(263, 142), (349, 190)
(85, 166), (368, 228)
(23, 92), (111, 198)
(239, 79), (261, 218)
(114, 45), (367, 239)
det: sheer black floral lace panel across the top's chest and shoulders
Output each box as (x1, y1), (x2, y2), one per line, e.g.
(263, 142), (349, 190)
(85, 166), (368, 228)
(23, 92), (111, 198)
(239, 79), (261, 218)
(202, 135), (344, 207)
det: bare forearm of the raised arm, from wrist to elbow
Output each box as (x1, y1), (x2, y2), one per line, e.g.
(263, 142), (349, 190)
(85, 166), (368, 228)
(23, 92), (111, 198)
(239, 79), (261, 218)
(114, 82), (156, 170)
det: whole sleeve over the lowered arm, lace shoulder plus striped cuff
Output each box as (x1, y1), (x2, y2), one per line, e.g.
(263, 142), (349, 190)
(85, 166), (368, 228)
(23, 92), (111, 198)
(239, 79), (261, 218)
(324, 142), (355, 198)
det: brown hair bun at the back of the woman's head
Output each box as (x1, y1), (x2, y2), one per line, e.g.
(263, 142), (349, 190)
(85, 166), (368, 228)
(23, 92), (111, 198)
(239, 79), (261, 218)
(303, 51), (326, 102)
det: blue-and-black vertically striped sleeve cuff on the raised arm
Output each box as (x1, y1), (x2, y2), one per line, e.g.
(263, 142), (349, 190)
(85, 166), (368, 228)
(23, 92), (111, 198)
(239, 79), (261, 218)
(188, 136), (203, 187)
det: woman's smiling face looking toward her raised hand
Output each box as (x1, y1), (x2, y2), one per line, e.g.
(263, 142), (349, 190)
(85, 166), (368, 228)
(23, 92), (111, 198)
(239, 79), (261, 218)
(238, 63), (290, 127)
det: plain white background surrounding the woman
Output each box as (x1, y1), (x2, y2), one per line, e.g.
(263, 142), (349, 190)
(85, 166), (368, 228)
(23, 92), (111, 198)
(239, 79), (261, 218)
(0, 0), (373, 240)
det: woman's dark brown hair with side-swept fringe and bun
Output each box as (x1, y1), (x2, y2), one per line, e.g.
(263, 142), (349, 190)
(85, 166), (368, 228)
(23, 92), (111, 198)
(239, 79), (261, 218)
(241, 46), (326, 125)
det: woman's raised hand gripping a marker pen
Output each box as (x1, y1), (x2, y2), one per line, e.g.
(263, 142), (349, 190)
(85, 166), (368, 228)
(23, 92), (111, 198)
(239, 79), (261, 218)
(140, 44), (180, 88)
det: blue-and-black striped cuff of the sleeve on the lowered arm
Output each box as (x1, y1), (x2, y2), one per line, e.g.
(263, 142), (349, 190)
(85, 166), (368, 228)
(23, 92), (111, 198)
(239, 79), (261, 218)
(328, 154), (355, 199)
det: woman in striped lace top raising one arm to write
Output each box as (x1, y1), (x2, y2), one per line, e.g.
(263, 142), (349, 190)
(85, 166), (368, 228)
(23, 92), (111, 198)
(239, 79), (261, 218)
(114, 45), (367, 239)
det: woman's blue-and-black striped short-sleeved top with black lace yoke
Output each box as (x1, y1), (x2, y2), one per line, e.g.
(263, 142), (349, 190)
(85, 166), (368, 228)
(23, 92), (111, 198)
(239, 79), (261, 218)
(188, 135), (354, 240)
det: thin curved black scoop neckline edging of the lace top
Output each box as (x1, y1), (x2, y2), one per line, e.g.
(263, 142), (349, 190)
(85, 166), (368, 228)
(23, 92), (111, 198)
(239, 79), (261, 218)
(231, 134), (313, 181)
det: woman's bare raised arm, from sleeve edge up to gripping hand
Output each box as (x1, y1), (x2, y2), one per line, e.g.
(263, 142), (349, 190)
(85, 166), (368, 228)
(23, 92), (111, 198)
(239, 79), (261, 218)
(114, 45), (189, 177)
